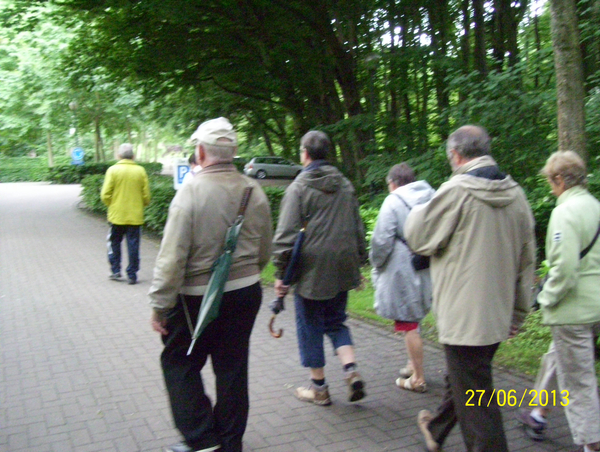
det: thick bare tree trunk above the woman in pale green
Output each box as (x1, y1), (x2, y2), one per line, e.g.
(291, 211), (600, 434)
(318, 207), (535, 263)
(550, 0), (587, 160)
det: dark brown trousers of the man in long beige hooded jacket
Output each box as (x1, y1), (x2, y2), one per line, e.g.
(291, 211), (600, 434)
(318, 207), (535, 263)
(429, 344), (508, 452)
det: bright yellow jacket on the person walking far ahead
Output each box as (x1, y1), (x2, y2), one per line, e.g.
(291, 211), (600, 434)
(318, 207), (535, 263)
(100, 159), (150, 226)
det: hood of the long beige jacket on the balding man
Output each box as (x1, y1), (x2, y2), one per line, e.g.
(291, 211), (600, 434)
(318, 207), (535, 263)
(449, 156), (521, 207)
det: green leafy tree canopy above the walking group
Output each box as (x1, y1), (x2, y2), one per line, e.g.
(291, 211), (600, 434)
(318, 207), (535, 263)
(0, 0), (600, 191)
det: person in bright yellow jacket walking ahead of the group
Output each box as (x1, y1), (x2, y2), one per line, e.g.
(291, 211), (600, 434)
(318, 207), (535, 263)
(100, 143), (150, 284)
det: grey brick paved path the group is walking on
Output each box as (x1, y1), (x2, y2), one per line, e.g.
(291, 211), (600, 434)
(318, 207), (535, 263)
(0, 183), (572, 452)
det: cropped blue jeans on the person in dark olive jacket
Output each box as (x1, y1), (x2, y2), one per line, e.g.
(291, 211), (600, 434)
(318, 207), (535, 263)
(294, 292), (352, 369)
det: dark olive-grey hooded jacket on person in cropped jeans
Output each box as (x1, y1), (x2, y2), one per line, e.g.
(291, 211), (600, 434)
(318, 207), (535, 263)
(273, 162), (367, 300)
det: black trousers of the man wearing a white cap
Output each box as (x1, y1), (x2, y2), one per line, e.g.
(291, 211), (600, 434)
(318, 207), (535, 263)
(161, 283), (262, 452)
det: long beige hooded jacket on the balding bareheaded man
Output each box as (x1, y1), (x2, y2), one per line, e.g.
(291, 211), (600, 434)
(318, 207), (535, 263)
(404, 156), (535, 346)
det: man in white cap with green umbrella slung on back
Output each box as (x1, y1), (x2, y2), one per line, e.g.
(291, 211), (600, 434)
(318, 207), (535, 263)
(149, 118), (272, 452)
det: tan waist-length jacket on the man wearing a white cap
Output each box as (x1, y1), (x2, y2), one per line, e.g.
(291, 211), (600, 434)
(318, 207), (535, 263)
(149, 164), (273, 309)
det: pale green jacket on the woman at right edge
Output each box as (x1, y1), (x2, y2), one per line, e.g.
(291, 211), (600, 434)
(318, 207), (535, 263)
(538, 186), (600, 325)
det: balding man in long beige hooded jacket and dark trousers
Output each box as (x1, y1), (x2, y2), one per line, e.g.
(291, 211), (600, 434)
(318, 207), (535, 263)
(404, 125), (535, 452)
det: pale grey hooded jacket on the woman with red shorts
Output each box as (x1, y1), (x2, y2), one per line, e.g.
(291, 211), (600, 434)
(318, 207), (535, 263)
(369, 181), (435, 322)
